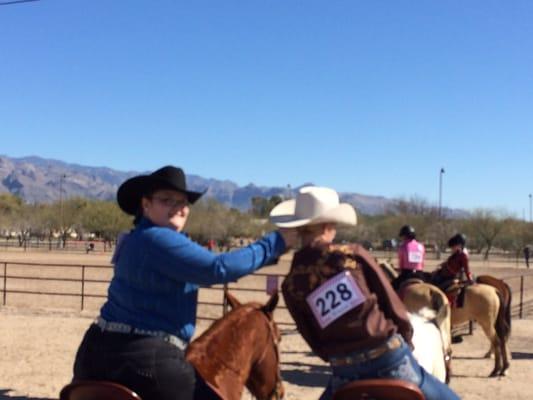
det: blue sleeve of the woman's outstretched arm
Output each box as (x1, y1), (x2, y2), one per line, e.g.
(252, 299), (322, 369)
(143, 228), (286, 285)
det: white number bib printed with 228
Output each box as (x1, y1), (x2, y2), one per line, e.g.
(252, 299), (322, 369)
(306, 271), (366, 329)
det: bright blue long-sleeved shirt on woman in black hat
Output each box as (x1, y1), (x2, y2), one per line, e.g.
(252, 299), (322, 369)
(101, 218), (285, 342)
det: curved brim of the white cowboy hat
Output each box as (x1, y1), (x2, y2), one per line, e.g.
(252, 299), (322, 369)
(270, 199), (357, 228)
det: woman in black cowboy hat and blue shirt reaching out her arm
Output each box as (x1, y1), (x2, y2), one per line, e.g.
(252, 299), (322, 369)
(73, 166), (297, 400)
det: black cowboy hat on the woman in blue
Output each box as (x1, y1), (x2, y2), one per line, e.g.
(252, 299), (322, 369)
(117, 165), (205, 215)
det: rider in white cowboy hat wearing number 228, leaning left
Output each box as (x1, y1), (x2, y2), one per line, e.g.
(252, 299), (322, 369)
(270, 187), (458, 400)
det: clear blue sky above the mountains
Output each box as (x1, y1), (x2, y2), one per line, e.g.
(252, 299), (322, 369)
(0, 0), (533, 218)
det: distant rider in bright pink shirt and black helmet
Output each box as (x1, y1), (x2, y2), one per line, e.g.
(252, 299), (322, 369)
(393, 225), (426, 289)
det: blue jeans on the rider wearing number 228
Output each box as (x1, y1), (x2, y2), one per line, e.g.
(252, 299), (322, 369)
(320, 334), (460, 400)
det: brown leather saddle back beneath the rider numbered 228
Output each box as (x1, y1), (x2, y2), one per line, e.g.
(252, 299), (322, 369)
(333, 379), (425, 400)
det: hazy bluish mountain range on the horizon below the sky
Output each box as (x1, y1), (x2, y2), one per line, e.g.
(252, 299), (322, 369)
(0, 155), (400, 215)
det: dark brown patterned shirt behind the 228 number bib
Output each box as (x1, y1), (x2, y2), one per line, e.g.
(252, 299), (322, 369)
(282, 243), (413, 361)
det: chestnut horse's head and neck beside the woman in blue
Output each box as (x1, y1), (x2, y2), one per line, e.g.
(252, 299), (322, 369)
(186, 292), (284, 400)
